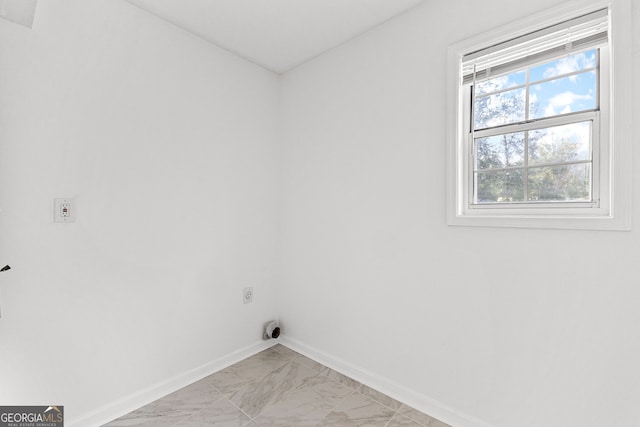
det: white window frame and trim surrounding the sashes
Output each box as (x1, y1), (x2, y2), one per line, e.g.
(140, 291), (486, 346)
(447, 0), (632, 230)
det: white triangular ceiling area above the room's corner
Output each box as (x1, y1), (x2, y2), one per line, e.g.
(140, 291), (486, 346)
(128, 0), (424, 73)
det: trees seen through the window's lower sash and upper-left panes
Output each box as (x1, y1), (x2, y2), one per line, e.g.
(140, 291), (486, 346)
(473, 79), (591, 203)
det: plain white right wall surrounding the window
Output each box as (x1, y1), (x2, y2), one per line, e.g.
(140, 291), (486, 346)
(280, 0), (640, 427)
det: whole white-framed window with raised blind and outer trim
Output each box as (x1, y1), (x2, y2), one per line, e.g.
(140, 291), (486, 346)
(448, 0), (630, 229)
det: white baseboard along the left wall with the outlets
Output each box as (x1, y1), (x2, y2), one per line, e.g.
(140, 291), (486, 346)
(65, 340), (277, 427)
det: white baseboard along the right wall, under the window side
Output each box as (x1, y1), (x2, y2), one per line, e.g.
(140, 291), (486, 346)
(279, 336), (493, 427)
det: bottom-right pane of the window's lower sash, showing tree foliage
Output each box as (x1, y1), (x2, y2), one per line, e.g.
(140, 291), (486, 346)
(528, 163), (591, 202)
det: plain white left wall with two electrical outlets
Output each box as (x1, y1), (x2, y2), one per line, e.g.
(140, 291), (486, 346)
(0, 0), (278, 425)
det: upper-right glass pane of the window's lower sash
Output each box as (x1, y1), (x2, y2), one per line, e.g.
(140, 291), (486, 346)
(529, 121), (591, 165)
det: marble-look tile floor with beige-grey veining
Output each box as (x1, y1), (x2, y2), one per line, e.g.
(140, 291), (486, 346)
(103, 344), (450, 427)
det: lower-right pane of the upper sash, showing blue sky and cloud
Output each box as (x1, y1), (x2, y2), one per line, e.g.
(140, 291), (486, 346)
(529, 71), (596, 119)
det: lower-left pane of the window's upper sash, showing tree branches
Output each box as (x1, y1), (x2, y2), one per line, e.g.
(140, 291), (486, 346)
(473, 89), (526, 129)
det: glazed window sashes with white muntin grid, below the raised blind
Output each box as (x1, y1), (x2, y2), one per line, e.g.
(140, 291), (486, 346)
(465, 48), (600, 208)
